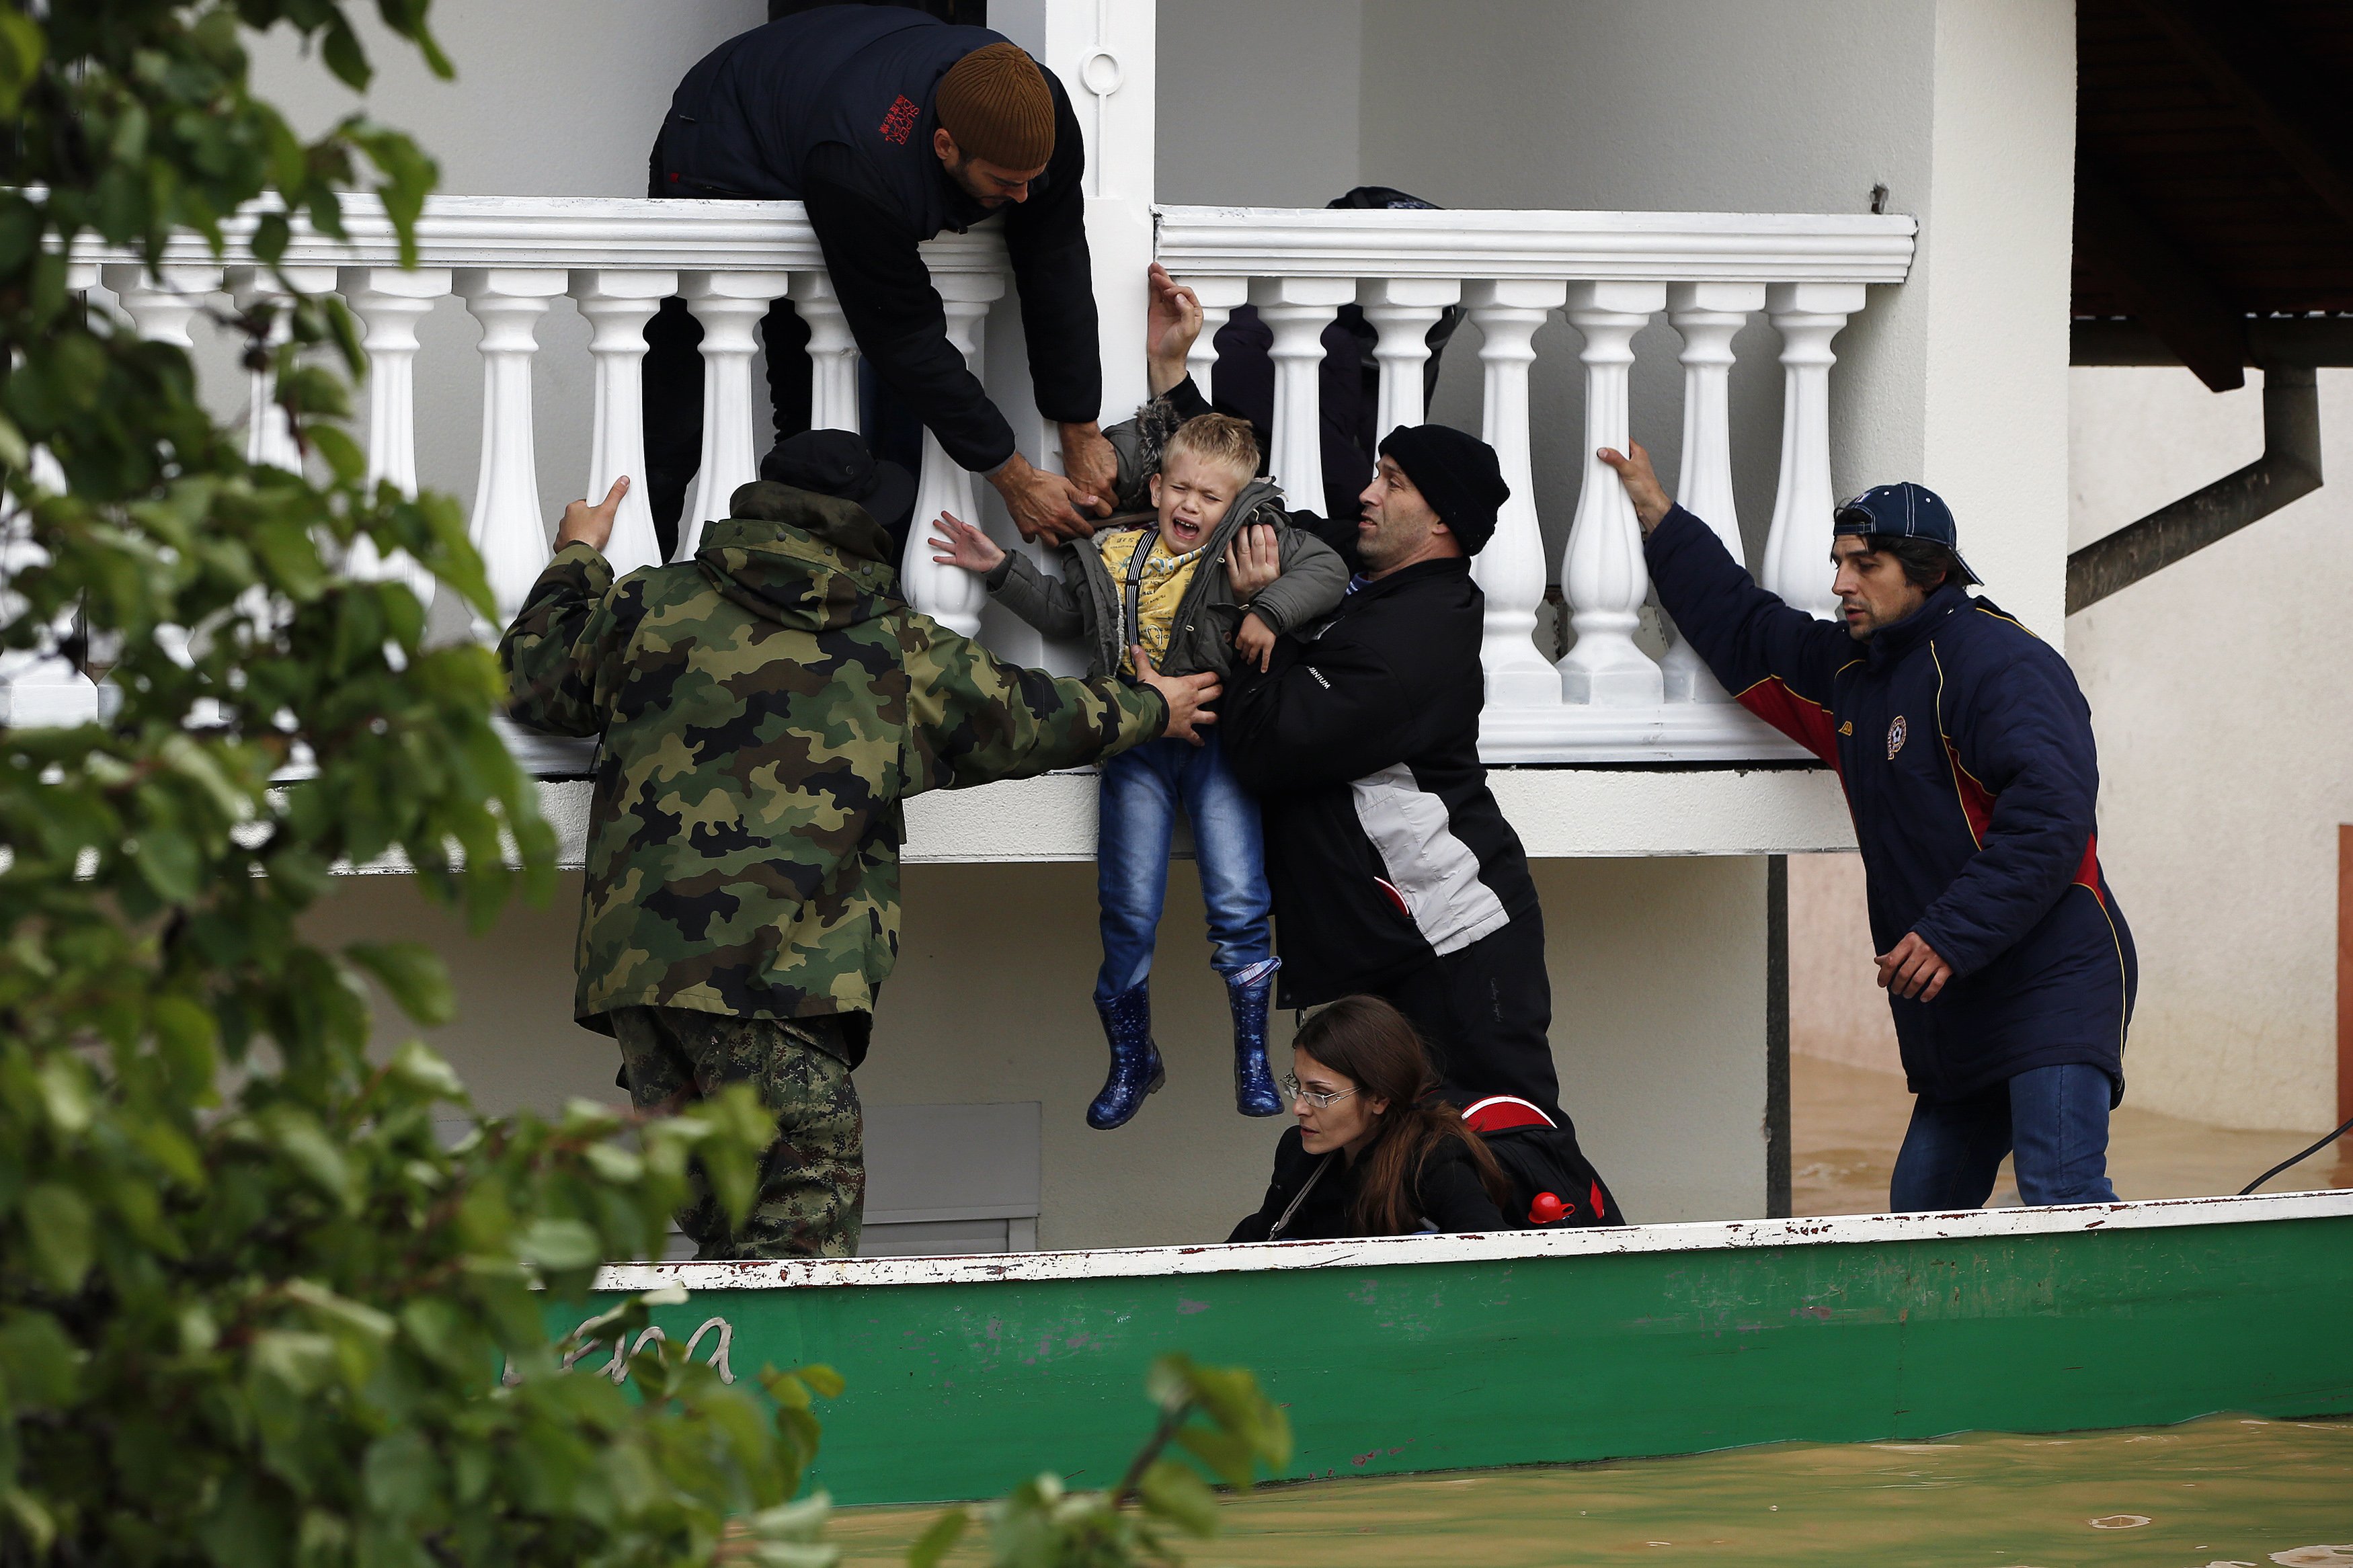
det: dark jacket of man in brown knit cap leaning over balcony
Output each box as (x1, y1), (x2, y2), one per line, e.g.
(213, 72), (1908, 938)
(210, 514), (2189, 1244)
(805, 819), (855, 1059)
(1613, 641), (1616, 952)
(654, 5), (1104, 470)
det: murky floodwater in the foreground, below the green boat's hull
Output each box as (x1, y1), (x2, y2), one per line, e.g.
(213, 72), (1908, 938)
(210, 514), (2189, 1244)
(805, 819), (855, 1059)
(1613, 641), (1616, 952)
(833, 1415), (2353, 1568)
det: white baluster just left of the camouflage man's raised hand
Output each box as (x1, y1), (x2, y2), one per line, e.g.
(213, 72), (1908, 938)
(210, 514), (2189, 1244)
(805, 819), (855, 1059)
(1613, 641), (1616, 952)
(456, 268), (565, 639)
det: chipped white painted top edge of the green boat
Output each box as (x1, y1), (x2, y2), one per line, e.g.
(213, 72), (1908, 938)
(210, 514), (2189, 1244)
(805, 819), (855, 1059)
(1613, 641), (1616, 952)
(596, 1192), (2353, 1290)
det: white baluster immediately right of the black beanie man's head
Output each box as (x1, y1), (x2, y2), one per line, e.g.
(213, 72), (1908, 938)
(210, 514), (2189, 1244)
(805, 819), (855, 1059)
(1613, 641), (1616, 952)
(1449, 278), (1570, 708)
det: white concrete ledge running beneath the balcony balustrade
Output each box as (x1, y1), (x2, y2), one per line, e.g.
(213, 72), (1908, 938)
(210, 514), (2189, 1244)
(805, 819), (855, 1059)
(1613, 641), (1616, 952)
(539, 766), (1854, 870)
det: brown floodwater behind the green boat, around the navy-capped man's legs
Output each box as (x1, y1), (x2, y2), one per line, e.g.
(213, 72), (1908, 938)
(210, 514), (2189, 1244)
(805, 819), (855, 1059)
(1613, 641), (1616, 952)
(1788, 1053), (2353, 1215)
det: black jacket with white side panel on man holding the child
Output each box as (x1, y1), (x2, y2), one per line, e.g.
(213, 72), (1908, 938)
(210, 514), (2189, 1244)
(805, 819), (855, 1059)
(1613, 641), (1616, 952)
(1219, 559), (1537, 1006)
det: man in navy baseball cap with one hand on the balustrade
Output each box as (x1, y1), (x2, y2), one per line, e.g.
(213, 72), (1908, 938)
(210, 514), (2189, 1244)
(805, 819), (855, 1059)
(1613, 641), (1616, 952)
(1600, 447), (2139, 1210)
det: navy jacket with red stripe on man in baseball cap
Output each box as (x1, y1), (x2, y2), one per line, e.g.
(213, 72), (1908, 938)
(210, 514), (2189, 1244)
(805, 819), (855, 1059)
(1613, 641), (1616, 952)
(1642, 505), (2139, 1100)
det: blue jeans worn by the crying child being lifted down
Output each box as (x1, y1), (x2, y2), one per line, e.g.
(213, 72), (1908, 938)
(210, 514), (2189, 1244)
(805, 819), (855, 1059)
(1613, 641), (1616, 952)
(1094, 731), (1273, 1001)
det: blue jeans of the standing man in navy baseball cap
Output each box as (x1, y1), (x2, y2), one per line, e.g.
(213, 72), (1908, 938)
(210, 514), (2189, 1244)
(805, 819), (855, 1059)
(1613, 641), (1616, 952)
(1887, 1063), (2116, 1213)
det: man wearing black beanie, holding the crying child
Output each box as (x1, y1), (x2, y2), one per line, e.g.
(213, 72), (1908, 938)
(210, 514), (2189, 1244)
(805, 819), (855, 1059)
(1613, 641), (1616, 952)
(1219, 404), (1567, 1126)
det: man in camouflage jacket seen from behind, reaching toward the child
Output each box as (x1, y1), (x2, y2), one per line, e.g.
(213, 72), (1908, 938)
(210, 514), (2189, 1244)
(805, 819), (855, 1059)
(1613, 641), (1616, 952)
(499, 460), (1217, 1257)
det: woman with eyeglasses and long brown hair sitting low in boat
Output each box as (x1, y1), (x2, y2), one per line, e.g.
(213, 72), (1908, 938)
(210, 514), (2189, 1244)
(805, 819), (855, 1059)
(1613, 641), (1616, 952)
(1226, 997), (1518, 1241)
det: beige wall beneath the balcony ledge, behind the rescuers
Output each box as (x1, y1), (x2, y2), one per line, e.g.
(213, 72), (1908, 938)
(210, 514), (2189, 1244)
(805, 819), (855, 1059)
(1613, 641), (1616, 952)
(311, 858), (1765, 1246)
